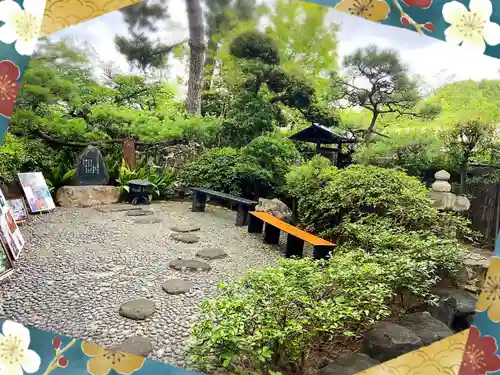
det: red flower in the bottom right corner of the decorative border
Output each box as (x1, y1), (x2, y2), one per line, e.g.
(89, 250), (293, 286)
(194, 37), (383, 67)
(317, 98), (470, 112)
(458, 326), (500, 375)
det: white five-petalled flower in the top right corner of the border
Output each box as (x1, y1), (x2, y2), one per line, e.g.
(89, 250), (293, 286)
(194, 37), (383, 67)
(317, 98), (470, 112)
(443, 0), (500, 53)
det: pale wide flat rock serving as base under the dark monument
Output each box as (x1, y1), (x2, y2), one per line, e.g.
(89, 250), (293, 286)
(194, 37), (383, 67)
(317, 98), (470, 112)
(56, 185), (120, 207)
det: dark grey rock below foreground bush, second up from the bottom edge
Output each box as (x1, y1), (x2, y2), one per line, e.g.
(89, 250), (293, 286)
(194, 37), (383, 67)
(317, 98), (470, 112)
(362, 322), (424, 362)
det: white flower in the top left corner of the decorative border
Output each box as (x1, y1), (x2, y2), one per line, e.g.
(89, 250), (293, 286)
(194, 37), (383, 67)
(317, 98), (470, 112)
(0, 0), (45, 56)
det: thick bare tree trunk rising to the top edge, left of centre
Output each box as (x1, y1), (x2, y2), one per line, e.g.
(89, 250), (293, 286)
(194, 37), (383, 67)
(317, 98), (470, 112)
(186, 0), (205, 115)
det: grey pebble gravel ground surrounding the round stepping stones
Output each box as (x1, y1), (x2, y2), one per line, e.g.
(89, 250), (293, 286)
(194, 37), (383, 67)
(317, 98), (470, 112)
(0, 202), (279, 367)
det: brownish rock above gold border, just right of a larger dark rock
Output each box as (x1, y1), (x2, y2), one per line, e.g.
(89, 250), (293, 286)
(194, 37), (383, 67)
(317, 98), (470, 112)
(399, 311), (453, 345)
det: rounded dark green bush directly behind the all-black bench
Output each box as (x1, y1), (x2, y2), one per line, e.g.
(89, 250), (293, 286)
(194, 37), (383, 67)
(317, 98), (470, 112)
(182, 147), (273, 198)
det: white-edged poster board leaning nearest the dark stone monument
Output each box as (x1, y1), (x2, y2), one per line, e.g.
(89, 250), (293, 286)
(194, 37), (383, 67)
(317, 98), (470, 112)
(18, 172), (56, 213)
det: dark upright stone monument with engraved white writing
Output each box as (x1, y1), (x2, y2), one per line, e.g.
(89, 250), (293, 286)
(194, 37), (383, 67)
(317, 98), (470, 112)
(75, 145), (109, 185)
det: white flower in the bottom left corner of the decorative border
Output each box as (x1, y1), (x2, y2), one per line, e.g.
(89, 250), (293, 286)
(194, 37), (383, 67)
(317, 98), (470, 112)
(0, 320), (41, 375)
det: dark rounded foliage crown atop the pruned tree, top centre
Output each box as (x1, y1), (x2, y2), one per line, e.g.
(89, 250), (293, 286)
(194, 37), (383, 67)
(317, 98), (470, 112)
(229, 30), (279, 65)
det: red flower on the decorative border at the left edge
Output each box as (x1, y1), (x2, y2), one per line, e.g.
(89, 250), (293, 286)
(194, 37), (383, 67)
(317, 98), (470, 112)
(0, 60), (21, 118)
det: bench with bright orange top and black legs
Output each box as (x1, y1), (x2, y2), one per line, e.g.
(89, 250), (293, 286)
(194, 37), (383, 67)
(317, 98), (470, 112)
(248, 211), (336, 259)
